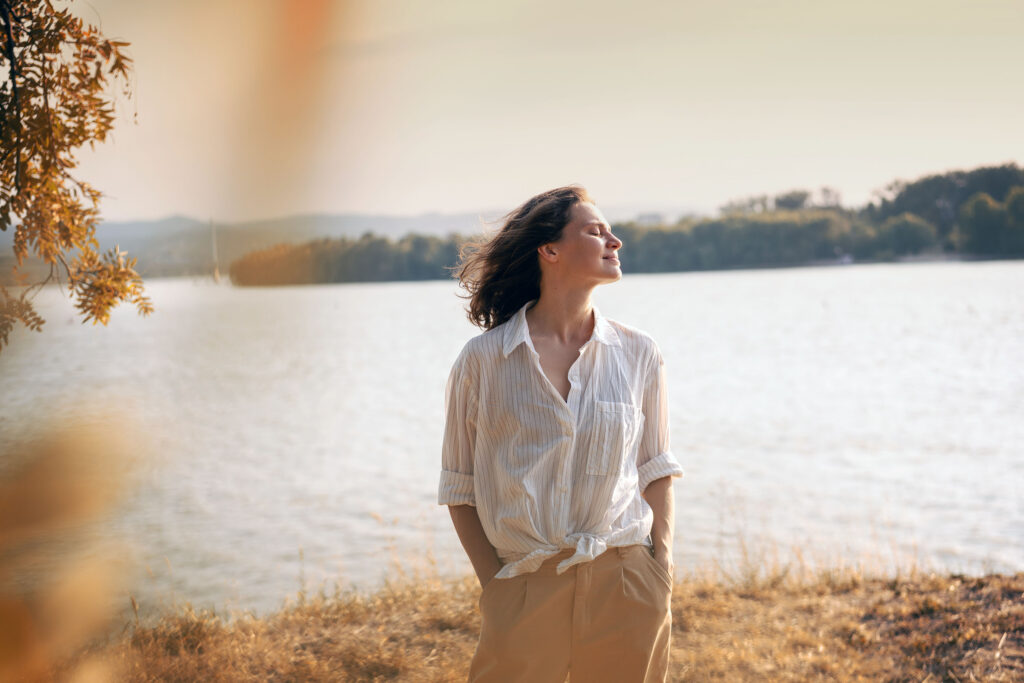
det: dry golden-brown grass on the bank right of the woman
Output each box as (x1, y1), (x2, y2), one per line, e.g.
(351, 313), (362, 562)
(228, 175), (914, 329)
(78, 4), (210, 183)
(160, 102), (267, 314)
(673, 570), (1024, 681)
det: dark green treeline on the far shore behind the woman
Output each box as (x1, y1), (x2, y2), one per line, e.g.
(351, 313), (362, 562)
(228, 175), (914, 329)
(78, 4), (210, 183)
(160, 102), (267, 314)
(230, 164), (1024, 286)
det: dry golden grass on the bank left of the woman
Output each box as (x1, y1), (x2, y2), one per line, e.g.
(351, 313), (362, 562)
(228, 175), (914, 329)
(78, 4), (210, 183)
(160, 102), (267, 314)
(103, 580), (479, 681)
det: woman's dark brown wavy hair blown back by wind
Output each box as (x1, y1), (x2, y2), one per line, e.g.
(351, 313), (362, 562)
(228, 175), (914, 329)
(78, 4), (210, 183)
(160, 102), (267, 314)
(455, 185), (593, 330)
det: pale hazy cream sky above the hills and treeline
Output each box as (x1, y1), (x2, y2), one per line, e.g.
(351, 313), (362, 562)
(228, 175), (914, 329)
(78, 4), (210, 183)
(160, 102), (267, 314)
(71, 0), (1024, 221)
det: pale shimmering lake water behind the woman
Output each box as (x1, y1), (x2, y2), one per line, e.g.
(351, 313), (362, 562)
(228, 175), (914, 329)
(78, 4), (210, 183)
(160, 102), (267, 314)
(0, 261), (1024, 611)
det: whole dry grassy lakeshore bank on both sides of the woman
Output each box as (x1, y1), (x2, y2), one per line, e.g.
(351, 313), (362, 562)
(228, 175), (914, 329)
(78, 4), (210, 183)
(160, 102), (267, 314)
(65, 569), (1024, 681)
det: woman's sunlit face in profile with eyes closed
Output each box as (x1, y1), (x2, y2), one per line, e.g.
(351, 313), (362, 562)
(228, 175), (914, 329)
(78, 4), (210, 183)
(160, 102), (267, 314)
(542, 202), (623, 285)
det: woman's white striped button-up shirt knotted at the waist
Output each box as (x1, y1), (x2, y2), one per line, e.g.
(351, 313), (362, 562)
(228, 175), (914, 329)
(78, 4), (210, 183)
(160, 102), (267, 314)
(437, 301), (683, 579)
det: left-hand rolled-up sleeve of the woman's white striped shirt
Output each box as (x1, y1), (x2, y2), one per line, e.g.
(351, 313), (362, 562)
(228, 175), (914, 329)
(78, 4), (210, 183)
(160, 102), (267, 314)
(437, 349), (477, 506)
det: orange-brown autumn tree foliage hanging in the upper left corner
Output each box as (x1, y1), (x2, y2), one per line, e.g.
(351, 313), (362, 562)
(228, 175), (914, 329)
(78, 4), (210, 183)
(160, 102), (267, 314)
(0, 0), (153, 349)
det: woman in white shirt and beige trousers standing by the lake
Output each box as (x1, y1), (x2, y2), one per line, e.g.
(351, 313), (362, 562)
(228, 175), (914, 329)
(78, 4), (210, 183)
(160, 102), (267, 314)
(438, 185), (682, 683)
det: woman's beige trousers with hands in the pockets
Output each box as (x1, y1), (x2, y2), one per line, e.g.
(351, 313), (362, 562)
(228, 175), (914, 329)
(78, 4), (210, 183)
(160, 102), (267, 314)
(469, 546), (672, 683)
